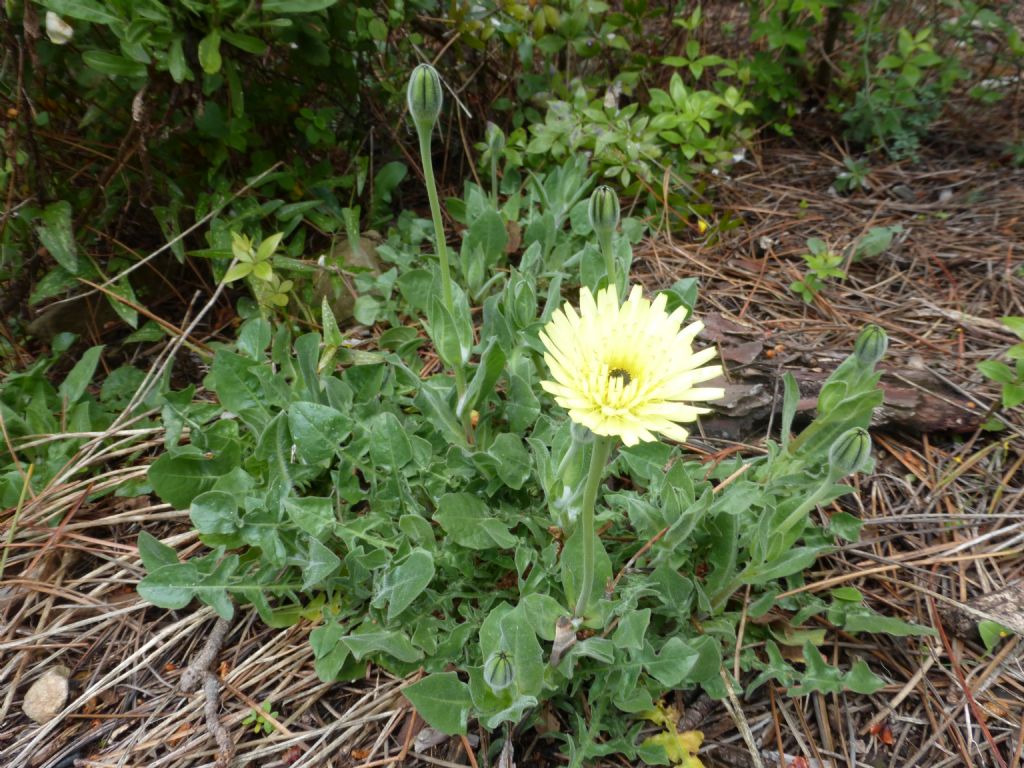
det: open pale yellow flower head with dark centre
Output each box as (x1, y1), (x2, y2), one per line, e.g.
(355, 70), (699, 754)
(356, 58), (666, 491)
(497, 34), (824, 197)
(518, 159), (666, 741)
(541, 286), (725, 445)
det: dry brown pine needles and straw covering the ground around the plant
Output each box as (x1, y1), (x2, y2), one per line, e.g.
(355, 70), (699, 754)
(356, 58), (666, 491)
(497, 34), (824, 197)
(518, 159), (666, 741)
(0, 137), (1024, 768)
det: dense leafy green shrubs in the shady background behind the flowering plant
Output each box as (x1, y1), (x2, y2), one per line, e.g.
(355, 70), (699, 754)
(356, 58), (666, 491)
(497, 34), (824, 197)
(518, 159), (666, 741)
(0, 0), (1024, 339)
